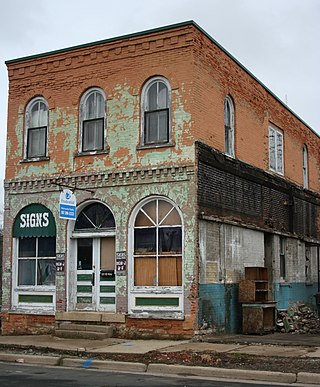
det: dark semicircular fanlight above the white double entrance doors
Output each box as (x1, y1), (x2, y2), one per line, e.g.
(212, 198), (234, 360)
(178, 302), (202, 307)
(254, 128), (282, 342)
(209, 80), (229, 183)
(75, 202), (115, 231)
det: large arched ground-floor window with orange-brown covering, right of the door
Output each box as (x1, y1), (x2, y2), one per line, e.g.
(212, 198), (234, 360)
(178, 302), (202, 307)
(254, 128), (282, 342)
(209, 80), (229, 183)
(133, 199), (182, 287)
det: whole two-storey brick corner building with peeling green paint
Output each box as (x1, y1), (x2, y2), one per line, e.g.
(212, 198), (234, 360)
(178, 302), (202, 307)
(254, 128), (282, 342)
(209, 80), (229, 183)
(2, 21), (320, 337)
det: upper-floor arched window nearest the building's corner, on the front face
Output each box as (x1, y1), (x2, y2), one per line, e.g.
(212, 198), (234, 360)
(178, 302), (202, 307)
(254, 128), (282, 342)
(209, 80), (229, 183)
(141, 77), (171, 146)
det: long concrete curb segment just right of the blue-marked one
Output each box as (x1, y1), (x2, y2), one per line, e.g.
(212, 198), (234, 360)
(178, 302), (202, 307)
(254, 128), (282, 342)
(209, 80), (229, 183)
(147, 364), (297, 383)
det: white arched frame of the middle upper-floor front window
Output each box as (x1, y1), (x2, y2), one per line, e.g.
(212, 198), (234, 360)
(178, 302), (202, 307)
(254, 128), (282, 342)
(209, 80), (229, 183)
(78, 87), (107, 154)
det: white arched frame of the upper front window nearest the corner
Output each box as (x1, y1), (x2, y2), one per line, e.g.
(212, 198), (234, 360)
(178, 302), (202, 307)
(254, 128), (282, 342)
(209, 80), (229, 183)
(140, 76), (173, 148)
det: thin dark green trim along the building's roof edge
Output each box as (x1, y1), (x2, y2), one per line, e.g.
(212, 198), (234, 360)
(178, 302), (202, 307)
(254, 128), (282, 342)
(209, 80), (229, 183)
(5, 20), (320, 138)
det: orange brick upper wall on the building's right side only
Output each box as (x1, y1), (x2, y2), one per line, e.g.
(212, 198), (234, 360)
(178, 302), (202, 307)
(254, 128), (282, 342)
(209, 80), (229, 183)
(192, 26), (320, 192)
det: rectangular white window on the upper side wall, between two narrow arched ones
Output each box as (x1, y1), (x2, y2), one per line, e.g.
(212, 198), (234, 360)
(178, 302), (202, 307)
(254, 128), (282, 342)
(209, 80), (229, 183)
(269, 125), (284, 175)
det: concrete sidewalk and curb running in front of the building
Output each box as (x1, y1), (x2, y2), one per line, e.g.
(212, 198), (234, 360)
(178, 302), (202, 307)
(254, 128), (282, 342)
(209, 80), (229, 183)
(0, 334), (320, 385)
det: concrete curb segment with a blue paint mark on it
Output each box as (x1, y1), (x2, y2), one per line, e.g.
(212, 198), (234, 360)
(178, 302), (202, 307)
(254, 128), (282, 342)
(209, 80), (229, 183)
(60, 358), (147, 373)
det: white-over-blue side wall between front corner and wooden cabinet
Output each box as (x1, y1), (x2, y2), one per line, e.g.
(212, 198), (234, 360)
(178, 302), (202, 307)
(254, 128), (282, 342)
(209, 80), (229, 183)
(198, 220), (265, 332)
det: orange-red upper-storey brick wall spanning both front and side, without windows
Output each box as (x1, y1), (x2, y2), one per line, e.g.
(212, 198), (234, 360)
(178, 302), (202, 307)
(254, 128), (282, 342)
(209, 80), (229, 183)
(6, 22), (320, 192)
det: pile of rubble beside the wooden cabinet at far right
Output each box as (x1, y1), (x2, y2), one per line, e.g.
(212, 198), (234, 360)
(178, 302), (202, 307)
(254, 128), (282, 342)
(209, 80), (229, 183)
(277, 303), (320, 334)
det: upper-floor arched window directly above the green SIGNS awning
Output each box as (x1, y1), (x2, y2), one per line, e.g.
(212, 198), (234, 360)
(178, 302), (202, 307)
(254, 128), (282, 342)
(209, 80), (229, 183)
(25, 97), (49, 159)
